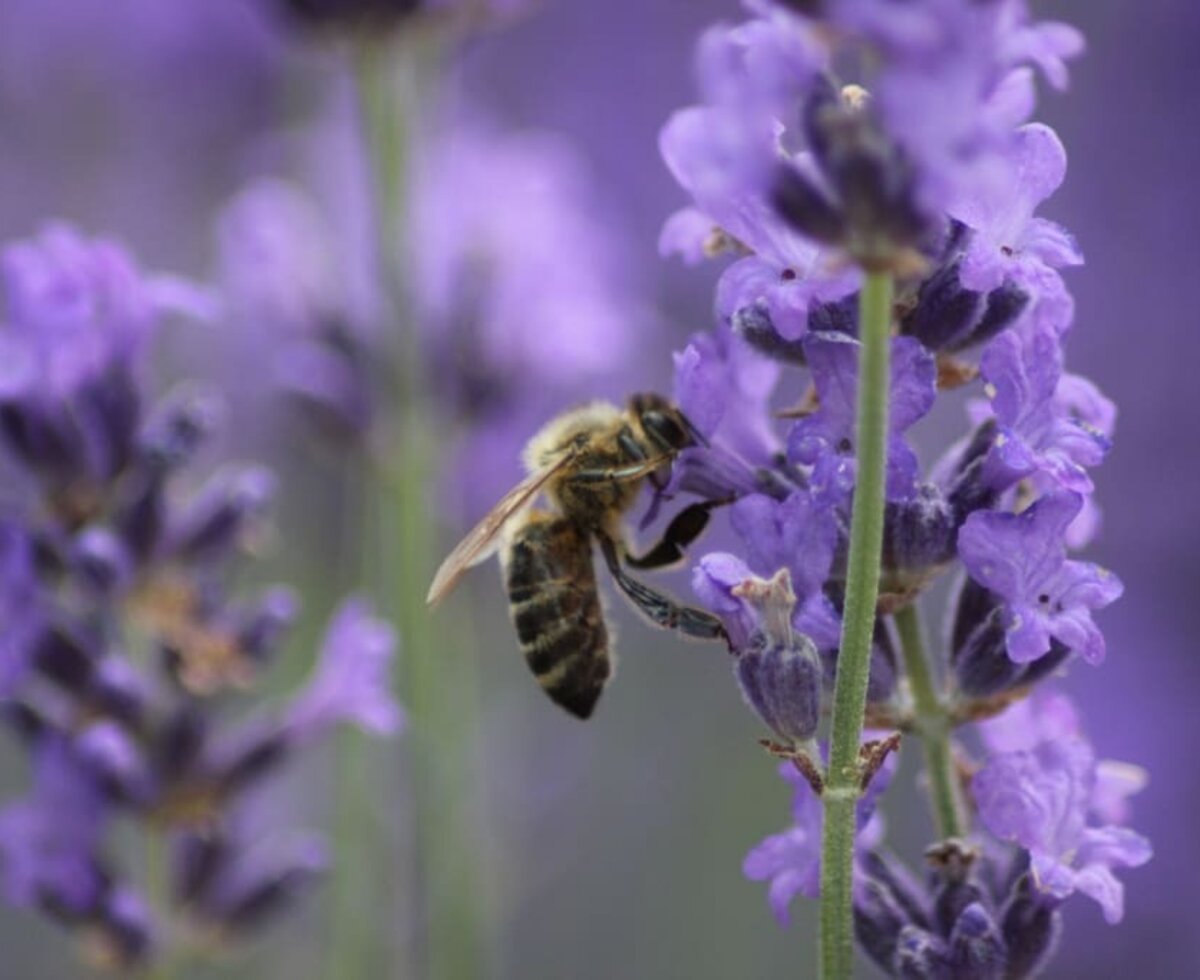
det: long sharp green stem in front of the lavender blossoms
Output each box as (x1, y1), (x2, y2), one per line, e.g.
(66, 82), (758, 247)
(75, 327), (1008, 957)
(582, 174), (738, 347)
(820, 272), (893, 980)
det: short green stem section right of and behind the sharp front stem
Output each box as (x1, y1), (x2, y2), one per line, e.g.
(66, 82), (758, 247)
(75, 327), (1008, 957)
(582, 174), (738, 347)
(895, 603), (965, 838)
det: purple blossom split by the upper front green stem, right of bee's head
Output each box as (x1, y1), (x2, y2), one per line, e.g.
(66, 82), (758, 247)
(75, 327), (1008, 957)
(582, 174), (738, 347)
(787, 332), (937, 500)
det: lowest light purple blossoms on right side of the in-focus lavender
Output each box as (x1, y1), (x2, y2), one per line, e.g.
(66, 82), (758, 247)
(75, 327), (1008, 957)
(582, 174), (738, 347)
(972, 698), (1152, 924)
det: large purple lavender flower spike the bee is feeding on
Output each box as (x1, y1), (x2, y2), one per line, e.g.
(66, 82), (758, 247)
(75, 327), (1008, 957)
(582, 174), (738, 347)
(655, 0), (1150, 978)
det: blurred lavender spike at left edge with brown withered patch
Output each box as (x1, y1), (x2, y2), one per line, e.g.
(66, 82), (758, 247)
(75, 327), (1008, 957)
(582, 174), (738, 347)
(0, 226), (401, 969)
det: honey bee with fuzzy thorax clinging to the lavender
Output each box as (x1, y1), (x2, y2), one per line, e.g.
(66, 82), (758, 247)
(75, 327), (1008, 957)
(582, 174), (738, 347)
(427, 393), (728, 719)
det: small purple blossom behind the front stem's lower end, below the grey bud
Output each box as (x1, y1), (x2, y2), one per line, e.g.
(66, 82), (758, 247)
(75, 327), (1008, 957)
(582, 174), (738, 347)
(742, 756), (895, 925)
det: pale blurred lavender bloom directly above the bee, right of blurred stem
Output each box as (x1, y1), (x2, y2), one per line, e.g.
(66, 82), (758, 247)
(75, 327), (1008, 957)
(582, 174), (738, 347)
(409, 120), (654, 515)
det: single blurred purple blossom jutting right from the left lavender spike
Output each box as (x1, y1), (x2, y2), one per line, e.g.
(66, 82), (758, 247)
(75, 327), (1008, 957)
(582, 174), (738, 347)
(288, 600), (404, 739)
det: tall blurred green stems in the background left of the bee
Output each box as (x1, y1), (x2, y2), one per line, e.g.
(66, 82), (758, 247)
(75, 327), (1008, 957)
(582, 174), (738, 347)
(329, 36), (488, 980)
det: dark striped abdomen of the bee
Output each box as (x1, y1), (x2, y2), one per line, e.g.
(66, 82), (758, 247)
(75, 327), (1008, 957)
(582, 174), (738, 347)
(504, 512), (612, 719)
